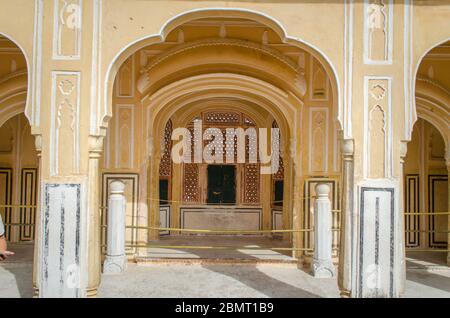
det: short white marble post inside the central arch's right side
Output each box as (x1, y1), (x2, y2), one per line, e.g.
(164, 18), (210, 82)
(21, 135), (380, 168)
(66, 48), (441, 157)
(313, 183), (335, 278)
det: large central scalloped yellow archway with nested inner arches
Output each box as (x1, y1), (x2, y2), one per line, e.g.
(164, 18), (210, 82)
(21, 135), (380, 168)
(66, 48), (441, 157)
(102, 10), (341, 262)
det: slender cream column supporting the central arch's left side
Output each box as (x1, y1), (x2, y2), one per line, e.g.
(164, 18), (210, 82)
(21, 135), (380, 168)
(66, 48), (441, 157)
(86, 136), (103, 297)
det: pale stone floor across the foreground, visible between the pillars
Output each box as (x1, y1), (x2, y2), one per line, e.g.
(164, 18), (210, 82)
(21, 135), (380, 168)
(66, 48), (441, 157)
(0, 241), (450, 298)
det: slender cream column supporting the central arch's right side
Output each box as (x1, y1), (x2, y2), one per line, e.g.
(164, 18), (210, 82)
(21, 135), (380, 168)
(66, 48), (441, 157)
(338, 139), (354, 297)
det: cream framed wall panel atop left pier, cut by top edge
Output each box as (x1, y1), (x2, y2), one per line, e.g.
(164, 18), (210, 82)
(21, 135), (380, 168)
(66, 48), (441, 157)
(53, 0), (83, 60)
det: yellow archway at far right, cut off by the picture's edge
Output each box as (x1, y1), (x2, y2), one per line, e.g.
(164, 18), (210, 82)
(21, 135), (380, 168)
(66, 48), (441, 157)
(404, 39), (450, 263)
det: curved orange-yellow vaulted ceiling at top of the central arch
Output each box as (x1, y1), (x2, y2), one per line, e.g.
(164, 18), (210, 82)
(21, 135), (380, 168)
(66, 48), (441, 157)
(123, 18), (328, 98)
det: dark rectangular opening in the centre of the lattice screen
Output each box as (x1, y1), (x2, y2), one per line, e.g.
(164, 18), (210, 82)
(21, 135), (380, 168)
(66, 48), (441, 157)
(207, 165), (236, 204)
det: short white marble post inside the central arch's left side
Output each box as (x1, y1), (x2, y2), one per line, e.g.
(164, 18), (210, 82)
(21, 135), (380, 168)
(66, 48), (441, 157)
(103, 180), (127, 273)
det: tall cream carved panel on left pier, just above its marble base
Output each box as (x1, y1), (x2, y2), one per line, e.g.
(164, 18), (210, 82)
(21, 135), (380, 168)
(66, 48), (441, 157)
(50, 71), (81, 176)
